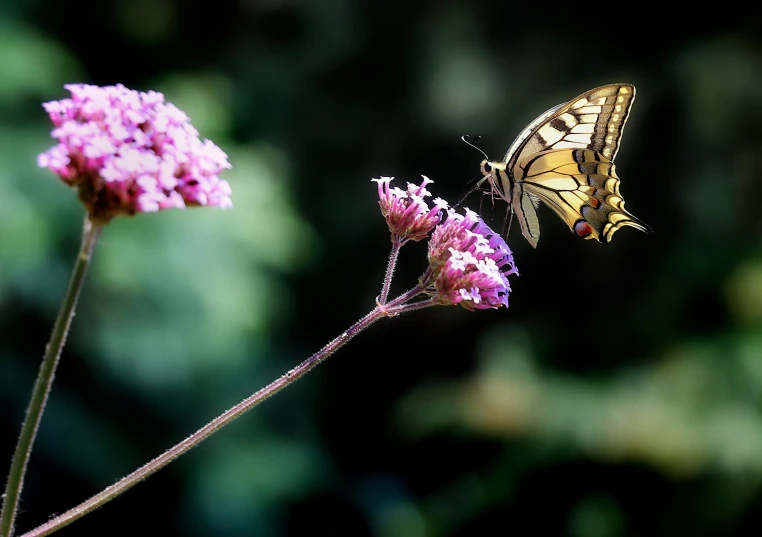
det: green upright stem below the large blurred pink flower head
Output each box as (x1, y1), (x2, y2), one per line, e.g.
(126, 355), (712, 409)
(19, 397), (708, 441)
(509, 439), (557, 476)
(0, 219), (103, 537)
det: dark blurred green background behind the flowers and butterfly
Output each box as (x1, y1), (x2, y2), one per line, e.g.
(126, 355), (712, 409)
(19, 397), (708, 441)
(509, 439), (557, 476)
(0, 0), (762, 537)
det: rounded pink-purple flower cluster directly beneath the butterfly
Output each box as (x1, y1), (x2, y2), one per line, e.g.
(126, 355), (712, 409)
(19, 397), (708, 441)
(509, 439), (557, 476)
(424, 209), (518, 310)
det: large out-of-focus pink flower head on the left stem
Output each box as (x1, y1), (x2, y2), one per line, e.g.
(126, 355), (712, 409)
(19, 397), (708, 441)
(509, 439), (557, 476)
(37, 84), (233, 222)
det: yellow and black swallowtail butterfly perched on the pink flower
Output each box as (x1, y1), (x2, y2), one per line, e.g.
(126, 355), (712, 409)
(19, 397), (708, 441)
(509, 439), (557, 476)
(463, 84), (651, 247)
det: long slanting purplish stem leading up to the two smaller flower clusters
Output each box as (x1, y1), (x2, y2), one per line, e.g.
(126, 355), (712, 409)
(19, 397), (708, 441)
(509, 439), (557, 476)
(21, 286), (422, 537)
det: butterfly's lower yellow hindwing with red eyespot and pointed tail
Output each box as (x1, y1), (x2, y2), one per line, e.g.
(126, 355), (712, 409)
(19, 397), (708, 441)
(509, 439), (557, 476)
(512, 149), (651, 246)
